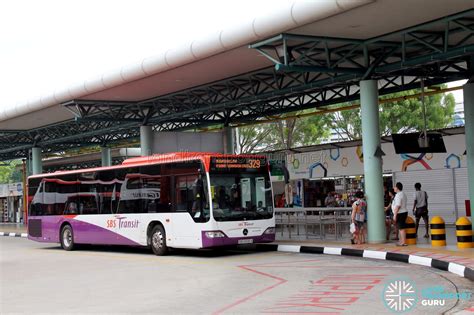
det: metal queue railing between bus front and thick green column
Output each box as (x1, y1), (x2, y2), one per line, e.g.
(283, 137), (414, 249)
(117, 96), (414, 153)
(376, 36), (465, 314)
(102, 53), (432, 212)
(275, 207), (352, 240)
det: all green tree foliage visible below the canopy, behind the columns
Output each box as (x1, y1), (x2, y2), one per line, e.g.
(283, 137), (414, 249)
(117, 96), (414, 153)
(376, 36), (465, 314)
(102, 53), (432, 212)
(238, 86), (455, 153)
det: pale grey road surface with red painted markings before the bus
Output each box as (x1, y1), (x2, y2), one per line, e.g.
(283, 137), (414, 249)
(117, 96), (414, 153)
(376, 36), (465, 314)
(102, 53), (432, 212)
(0, 237), (474, 314)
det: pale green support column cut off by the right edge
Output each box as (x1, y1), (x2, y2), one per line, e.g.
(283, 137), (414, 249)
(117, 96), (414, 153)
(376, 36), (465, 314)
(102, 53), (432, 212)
(463, 82), (474, 222)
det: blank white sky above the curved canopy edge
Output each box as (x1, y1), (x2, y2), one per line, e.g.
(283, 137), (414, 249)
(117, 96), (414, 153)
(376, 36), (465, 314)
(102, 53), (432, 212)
(0, 0), (293, 107)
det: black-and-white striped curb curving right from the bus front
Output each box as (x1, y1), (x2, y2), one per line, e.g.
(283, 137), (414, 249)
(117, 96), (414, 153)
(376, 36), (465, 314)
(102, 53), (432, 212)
(256, 244), (474, 281)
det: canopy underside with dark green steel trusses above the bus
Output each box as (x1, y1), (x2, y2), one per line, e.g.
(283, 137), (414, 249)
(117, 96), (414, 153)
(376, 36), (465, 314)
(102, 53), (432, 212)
(0, 0), (474, 160)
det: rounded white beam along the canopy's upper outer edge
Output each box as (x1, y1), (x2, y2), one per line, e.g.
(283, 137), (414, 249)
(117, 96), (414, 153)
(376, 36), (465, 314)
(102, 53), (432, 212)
(0, 0), (375, 122)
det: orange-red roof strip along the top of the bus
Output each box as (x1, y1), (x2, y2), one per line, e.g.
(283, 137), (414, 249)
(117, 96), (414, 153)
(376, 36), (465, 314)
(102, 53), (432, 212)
(28, 152), (266, 178)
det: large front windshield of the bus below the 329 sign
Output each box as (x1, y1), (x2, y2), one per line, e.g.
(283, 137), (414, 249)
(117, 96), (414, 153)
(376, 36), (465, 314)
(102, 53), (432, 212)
(210, 158), (273, 221)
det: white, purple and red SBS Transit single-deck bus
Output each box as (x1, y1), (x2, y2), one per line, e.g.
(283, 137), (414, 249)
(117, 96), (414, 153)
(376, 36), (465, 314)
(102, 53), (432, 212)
(27, 152), (275, 255)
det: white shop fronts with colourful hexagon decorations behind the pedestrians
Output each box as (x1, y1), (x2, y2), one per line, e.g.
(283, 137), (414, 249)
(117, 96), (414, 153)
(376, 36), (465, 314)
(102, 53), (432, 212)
(273, 133), (468, 224)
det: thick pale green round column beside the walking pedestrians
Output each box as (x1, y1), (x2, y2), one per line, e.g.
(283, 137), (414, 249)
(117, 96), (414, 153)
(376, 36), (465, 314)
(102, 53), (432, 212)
(360, 80), (385, 243)
